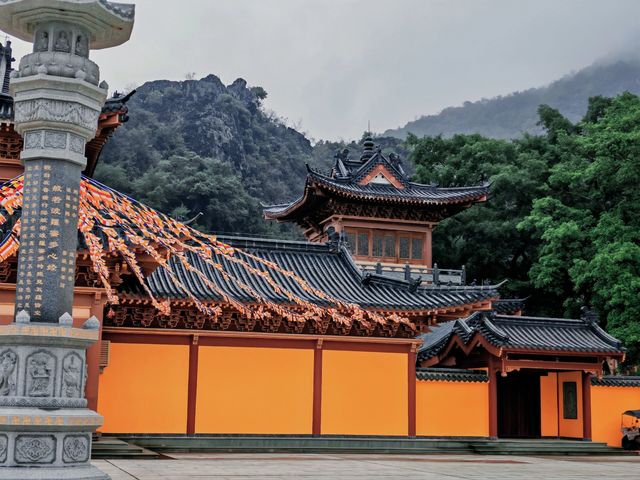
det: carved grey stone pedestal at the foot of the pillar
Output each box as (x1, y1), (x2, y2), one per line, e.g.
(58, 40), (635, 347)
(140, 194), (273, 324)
(0, 322), (104, 472)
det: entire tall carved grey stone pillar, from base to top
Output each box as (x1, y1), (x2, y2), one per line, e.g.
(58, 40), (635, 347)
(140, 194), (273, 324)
(0, 0), (134, 479)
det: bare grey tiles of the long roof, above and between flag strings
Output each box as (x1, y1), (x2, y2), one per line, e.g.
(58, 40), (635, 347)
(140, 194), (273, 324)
(128, 237), (498, 313)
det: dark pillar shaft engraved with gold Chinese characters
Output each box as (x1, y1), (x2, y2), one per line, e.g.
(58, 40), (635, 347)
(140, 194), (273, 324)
(16, 160), (80, 323)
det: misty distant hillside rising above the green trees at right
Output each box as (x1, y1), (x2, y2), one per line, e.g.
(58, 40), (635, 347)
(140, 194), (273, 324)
(385, 60), (640, 139)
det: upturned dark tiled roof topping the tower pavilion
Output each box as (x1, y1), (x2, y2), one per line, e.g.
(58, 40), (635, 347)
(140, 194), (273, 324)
(264, 139), (489, 230)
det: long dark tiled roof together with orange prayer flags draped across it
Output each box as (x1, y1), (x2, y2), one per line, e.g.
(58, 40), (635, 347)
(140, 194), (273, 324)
(0, 176), (498, 336)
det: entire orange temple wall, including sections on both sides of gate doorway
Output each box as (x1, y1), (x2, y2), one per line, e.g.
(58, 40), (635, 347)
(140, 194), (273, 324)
(98, 334), (640, 440)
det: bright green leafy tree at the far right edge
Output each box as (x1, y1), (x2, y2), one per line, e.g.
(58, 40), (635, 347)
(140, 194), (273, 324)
(520, 93), (640, 358)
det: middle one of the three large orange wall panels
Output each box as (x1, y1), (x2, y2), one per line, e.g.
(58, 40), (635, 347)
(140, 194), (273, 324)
(195, 347), (313, 434)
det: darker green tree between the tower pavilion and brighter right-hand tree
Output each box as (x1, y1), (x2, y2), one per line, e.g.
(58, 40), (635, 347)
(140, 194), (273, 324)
(407, 131), (554, 313)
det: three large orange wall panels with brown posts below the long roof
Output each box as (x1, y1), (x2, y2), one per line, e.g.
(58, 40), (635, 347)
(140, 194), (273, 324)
(98, 333), (413, 436)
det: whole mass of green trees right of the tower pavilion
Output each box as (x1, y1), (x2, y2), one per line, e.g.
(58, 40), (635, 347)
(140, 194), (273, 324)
(407, 93), (640, 364)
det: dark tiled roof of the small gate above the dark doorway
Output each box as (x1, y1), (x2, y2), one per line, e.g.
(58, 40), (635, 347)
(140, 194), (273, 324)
(418, 312), (624, 364)
